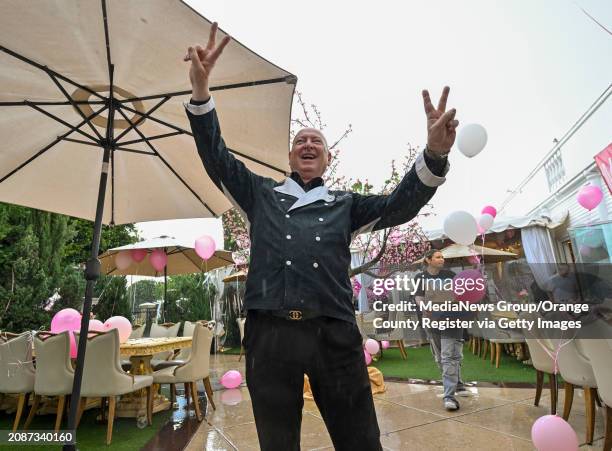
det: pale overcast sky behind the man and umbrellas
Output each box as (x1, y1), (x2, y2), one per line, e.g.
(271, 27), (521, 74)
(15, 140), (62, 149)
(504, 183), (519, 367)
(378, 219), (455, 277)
(139, 0), (612, 247)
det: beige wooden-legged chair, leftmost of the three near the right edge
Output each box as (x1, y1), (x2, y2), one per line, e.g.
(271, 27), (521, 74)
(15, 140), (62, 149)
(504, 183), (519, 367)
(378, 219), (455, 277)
(519, 313), (558, 415)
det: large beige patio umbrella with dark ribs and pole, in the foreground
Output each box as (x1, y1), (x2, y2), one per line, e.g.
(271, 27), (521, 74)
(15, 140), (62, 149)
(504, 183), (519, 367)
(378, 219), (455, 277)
(0, 0), (296, 449)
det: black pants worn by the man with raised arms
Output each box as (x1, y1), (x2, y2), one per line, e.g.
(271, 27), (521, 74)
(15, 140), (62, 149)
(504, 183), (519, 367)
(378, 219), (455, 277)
(243, 310), (382, 451)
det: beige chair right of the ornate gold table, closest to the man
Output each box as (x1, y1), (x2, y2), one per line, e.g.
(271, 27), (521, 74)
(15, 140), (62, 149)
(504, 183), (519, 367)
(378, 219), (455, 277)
(153, 323), (216, 421)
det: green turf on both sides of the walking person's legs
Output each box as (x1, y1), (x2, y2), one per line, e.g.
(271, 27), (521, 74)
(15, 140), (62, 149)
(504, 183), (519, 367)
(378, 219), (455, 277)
(372, 345), (536, 384)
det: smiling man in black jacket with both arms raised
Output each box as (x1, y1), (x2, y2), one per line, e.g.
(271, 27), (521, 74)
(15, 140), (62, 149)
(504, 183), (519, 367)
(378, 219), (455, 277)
(185, 24), (458, 451)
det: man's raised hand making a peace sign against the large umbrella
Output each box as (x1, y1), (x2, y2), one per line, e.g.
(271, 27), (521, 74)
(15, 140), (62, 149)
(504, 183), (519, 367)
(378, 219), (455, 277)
(183, 22), (231, 101)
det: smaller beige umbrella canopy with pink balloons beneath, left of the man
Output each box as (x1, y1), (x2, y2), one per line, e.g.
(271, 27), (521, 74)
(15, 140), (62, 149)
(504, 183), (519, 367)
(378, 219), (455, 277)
(98, 236), (234, 277)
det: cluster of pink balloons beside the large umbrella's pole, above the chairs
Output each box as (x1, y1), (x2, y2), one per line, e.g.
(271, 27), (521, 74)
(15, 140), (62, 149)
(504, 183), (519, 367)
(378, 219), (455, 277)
(51, 308), (132, 359)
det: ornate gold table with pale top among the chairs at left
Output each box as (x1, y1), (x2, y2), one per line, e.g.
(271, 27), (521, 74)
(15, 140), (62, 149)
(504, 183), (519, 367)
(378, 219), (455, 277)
(116, 337), (192, 421)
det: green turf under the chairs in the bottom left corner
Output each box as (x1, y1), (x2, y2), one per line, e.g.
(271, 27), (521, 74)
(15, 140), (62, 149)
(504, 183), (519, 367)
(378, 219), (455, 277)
(0, 398), (171, 451)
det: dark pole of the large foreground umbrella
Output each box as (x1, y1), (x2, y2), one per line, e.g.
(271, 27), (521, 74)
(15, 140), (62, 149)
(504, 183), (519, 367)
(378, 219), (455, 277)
(63, 61), (115, 451)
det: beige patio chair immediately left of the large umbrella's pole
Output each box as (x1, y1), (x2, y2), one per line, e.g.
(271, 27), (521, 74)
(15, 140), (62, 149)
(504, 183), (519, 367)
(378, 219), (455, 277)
(24, 331), (74, 432)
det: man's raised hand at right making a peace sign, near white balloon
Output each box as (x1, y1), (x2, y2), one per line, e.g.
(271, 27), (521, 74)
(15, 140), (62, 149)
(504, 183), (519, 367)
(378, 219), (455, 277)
(423, 86), (459, 157)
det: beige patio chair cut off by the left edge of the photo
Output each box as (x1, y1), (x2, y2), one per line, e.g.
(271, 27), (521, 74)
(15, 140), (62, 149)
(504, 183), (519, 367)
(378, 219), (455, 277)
(0, 332), (35, 432)
